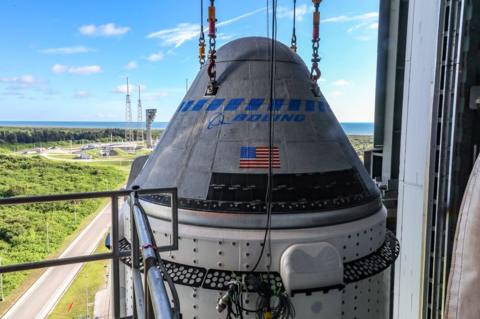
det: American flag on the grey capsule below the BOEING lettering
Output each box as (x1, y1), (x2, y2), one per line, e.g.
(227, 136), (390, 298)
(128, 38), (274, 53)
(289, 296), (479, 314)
(240, 146), (280, 168)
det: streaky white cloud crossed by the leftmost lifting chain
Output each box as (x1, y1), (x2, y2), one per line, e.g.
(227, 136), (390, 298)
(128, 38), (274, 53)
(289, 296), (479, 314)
(147, 8), (266, 48)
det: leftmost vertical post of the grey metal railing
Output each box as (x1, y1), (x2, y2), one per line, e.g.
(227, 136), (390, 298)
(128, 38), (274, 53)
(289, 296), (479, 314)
(110, 195), (120, 318)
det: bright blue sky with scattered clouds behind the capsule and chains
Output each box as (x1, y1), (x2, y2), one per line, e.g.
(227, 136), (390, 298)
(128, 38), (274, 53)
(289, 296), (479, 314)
(0, 0), (378, 122)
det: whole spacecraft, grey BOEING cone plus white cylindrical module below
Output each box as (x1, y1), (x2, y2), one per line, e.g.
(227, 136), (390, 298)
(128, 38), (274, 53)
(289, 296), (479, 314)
(118, 37), (399, 319)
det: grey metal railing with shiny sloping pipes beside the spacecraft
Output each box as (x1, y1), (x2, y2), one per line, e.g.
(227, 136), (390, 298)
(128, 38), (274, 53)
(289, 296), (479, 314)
(0, 188), (178, 319)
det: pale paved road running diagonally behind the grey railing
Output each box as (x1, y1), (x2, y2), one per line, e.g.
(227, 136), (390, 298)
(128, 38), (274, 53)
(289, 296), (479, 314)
(2, 203), (111, 319)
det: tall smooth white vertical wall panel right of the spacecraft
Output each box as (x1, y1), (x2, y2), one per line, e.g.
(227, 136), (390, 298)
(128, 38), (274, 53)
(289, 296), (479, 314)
(394, 0), (441, 319)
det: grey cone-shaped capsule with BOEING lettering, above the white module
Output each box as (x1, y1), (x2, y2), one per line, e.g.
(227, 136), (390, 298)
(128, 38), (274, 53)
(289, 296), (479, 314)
(135, 37), (379, 226)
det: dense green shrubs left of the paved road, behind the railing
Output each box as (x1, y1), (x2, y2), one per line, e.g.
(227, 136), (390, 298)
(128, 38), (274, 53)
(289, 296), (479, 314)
(0, 154), (127, 305)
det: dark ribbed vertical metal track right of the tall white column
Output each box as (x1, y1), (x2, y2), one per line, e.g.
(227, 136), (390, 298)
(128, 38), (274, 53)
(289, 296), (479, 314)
(423, 0), (465, 319)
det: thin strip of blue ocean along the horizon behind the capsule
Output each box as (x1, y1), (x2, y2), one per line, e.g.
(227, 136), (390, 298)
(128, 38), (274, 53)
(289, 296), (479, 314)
(0, 121), (373, 135)
